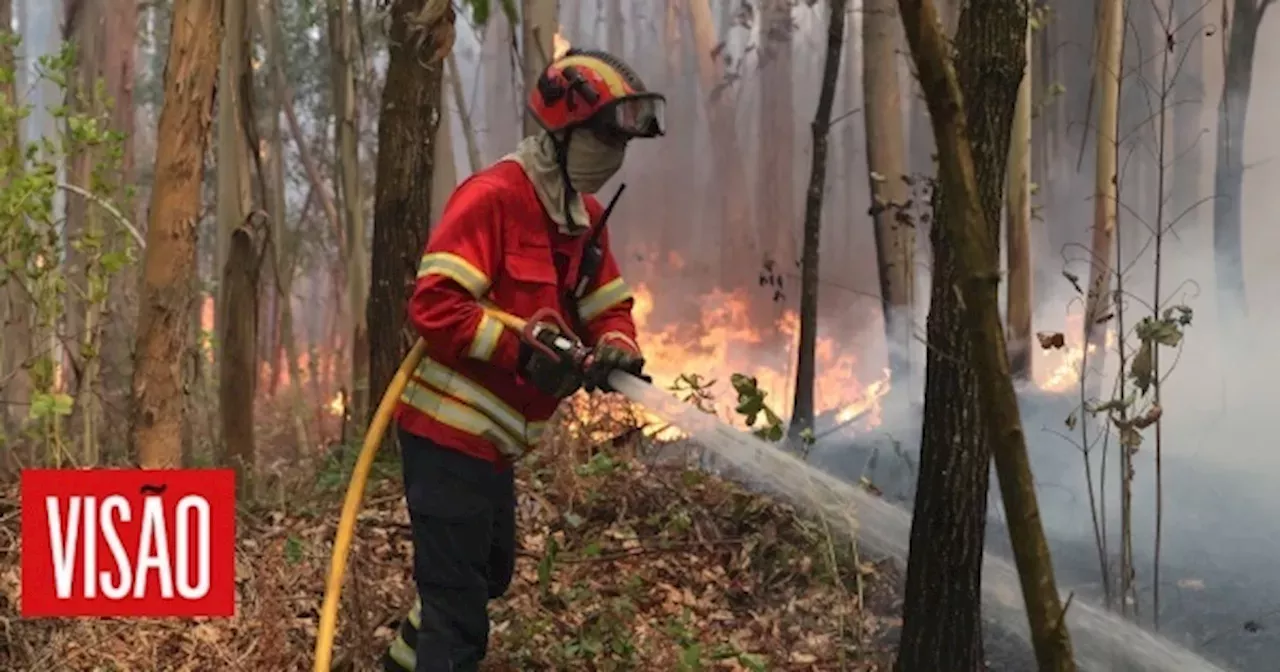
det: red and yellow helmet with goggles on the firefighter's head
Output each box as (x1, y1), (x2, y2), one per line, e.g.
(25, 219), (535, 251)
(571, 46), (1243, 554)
(529, 49), (667, 140)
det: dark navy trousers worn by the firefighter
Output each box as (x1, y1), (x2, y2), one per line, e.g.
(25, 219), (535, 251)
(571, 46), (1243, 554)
(388, 430), (516, 672)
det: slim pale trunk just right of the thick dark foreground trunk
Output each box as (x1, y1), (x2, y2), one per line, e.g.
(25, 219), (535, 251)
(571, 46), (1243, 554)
(1005, 22), (1033, 380)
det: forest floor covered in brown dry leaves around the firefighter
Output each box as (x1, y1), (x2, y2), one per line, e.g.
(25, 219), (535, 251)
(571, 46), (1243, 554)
(0, 412), (921, 671)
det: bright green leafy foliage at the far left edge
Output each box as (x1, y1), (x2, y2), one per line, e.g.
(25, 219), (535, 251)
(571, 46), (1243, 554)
(0, 44), (134, 465)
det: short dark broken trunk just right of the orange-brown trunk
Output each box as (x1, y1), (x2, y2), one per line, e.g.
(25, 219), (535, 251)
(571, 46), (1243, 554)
(218, 227), (261, 500)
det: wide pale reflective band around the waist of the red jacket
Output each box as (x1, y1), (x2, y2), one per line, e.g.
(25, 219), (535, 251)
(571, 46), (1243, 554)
(401, 357), (547, 458)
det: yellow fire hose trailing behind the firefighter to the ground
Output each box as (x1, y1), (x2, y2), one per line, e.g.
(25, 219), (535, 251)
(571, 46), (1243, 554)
(312, 306), (536, 672)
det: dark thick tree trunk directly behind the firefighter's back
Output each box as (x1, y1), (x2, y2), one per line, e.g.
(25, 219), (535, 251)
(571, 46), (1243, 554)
(369, 0), (454, 432)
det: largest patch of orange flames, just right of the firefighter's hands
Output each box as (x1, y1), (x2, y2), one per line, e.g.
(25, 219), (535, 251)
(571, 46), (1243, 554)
(632, 279), (890, 438)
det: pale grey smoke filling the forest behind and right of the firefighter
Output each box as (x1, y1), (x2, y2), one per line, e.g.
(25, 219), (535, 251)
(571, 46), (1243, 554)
(453, 3), (1280, 671)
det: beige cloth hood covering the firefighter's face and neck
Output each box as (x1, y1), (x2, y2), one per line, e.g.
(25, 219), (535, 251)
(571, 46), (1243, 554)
(504, 131), (626, 236)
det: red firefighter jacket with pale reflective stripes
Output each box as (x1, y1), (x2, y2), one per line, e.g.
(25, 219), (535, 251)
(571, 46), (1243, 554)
(396, 160), (640, 465)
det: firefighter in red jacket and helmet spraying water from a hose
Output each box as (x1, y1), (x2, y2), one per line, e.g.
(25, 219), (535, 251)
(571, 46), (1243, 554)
(384, 50), (666, 672)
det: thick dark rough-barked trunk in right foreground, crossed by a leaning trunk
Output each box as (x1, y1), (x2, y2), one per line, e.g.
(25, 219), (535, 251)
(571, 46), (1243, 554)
(899, 0), (1027, 672)
